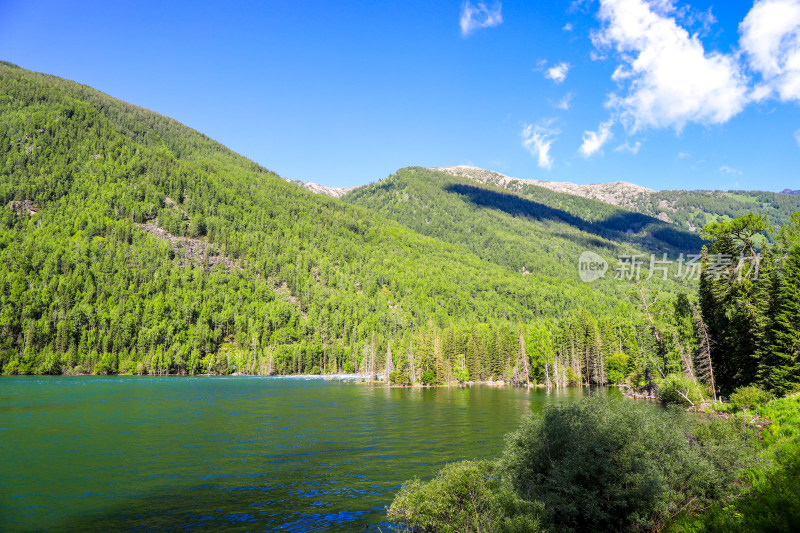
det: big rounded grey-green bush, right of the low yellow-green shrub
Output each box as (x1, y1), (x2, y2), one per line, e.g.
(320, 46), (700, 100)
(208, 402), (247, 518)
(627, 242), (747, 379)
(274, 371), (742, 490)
(500, 396), (755, 531)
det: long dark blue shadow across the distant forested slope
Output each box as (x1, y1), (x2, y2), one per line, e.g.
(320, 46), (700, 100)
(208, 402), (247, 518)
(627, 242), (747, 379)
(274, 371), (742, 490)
(445, 184), (703, 253)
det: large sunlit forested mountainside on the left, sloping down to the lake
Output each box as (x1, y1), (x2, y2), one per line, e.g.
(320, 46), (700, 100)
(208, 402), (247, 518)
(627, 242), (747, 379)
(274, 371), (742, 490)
(0, 63), (668, 381)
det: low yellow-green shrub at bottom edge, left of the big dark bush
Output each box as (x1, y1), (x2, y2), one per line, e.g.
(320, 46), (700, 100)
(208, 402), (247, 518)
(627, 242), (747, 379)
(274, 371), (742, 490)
(388, 461), (541, 533)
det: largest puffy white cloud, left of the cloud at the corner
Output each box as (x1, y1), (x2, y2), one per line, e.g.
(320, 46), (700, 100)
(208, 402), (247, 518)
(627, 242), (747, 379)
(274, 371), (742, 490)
(592, 0), (747, 131)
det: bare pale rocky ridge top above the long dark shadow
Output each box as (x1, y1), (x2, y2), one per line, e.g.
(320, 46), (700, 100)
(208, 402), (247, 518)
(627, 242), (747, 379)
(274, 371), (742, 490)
(431, 165), (656, 207)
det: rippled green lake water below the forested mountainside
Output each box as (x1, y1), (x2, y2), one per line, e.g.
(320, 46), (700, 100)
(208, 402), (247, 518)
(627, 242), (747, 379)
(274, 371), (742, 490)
(0, 376), (585, 532)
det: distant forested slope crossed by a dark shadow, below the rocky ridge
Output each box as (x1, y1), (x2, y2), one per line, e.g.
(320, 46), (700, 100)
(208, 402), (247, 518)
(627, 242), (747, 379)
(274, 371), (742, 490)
(343, 167), (702, 288)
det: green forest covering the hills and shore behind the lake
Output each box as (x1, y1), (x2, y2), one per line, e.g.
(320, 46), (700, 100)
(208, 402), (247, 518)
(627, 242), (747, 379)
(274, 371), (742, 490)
(0, 63), (800, 401)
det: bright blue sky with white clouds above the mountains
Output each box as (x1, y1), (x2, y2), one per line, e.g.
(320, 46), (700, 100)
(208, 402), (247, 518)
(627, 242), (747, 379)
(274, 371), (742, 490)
(0, 0), (800, 190)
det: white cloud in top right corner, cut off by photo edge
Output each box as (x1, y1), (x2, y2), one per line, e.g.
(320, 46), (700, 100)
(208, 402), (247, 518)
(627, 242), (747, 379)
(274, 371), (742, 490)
(739, 0), (800, 102)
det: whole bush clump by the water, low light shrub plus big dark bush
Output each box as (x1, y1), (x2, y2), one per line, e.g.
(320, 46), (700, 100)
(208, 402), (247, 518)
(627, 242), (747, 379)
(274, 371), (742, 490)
(390, 396), (757, 531)
